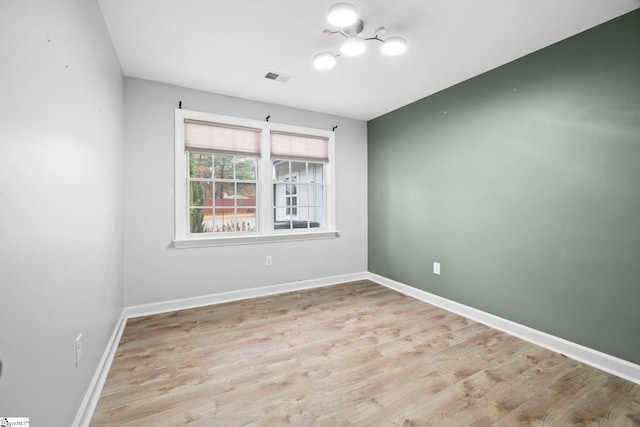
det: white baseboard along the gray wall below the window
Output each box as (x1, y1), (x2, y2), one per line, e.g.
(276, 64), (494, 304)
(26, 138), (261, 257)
(124, 272), (367, 319)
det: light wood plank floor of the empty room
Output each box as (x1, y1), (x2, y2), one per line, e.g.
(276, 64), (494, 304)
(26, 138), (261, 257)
(91, 281), (640, 427)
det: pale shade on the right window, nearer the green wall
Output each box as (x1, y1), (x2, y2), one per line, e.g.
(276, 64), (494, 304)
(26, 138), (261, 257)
(271, 131), (329, 162)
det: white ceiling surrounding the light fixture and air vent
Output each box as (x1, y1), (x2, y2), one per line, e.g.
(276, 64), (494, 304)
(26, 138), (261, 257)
(99, 0), (640, 120)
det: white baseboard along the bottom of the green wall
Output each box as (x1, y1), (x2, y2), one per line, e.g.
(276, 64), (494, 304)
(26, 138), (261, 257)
(367, 273), (640, 384)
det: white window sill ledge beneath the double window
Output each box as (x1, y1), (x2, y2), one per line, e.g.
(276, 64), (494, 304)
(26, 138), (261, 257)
(171, 230), (340, 249)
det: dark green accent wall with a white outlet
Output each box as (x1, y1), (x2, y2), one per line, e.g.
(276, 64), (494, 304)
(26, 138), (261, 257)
(368, 10), (640, 364)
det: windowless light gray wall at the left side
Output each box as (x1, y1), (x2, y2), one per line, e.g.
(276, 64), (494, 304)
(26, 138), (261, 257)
(0, 0), (124, 426)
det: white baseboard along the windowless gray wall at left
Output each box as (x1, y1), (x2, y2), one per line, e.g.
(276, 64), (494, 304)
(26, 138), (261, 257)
(72, 315), (127, 427)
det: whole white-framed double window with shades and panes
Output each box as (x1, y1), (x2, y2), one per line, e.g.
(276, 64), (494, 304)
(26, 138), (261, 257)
(175, 109), (336, 247)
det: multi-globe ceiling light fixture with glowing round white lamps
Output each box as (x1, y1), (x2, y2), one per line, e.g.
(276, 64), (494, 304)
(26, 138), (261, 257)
(313, 2), (407, 70)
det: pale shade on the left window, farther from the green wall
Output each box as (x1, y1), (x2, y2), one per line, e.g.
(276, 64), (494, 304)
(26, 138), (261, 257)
(184, 120), (261, 156)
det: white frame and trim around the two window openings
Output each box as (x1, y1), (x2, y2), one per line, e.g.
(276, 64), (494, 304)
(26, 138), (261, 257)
(173, 108), (338, 248)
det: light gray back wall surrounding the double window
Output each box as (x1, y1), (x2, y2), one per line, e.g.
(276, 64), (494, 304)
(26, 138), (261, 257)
(124, 78), (367, 305)
